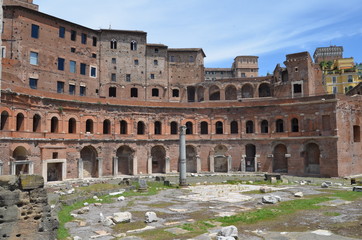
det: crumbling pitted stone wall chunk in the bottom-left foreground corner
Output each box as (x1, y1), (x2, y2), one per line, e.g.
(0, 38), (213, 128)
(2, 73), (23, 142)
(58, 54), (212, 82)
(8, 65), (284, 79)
(0, 175), (58, 240)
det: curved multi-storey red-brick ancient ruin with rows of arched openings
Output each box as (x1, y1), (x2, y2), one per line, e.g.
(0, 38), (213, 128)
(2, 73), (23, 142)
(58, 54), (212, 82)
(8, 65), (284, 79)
(0, 0), (362, 181)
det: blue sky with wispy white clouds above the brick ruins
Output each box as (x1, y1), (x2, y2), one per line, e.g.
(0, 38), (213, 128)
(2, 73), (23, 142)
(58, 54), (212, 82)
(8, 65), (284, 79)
(34, 0), (362, 75)
